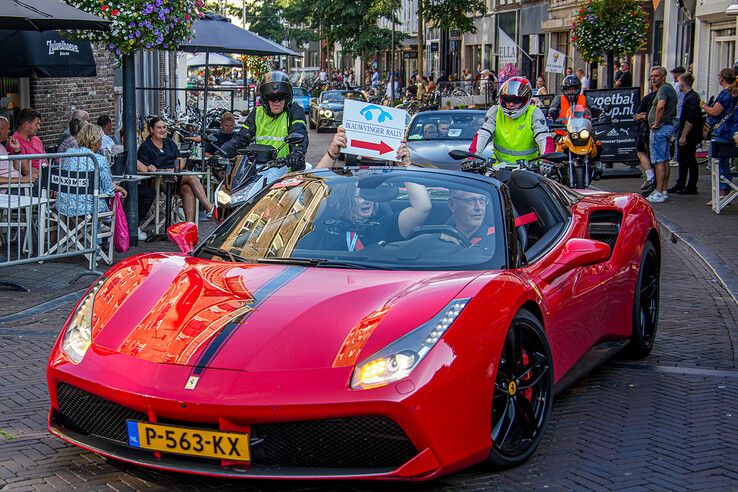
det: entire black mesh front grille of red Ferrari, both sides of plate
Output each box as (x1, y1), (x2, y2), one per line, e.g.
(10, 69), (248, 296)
(57, 383), (417, 468)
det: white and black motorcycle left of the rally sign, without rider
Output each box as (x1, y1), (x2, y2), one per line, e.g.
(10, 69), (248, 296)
(208, 133), (305, 220)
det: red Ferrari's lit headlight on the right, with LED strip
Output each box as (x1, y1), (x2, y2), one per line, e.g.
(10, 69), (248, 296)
(351, 298), (469, 390)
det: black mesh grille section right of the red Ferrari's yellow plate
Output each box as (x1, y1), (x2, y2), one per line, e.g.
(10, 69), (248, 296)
(252, 415), (417, 468)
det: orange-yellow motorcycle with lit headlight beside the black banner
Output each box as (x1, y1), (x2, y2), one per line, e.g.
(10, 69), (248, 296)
(538, 106), (611, 189)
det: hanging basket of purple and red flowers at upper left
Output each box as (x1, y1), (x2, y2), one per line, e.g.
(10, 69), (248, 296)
(66, 0), (205, 59)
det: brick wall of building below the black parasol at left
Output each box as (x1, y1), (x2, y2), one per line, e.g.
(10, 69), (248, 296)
(30, 45), (115, 146)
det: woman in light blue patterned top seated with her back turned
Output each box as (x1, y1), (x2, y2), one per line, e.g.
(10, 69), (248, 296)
(56, 123), (127, 217)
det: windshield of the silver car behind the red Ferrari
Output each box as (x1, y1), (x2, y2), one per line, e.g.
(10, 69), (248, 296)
(407, 111), (485, 140)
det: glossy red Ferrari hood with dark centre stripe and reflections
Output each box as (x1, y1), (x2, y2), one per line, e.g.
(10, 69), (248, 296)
(93, 254), (479, 371)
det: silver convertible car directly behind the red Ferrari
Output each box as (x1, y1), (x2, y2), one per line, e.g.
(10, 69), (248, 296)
(407, 109), (493, 171)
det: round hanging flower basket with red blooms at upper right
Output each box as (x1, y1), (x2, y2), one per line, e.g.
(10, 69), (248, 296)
(571, 0), (649, 62)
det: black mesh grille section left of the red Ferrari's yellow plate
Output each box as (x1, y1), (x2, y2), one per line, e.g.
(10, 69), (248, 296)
(56, 383), (147, 445)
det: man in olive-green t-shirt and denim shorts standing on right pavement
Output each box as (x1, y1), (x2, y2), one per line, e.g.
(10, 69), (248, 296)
(640, 63), (677, 203)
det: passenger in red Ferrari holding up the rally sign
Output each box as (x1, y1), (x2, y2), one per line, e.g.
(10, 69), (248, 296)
(300, 126), (431, 251)
